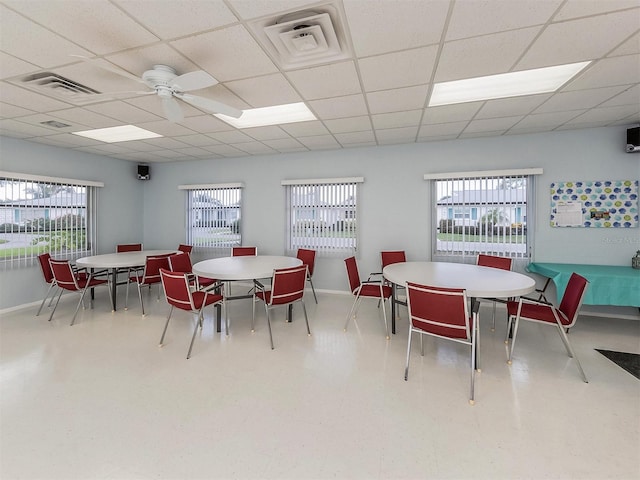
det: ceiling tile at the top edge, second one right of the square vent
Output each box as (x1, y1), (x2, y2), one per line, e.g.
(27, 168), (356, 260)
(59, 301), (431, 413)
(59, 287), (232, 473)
(446, 0), (562, 40)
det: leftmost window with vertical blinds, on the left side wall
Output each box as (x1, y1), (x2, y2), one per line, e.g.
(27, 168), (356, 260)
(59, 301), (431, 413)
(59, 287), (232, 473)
(0, 172), (103, 268)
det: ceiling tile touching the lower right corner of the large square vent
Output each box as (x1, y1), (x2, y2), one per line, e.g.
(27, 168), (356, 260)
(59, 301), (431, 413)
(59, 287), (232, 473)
(358, 46), (438, 92)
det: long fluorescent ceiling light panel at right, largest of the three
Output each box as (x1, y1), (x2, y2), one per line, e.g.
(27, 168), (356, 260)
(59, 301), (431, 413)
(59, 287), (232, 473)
(429, 62), (591, 107)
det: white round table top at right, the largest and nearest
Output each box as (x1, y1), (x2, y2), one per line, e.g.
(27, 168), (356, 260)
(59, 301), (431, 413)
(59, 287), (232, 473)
(382, 262), (536, 298)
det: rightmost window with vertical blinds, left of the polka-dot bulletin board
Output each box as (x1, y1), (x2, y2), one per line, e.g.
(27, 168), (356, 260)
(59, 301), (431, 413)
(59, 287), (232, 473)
(425, 169), (542, 267)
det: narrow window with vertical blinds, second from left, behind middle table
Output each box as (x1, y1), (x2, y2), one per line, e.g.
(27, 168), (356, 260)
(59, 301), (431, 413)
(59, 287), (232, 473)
(179, 183), (243, 257)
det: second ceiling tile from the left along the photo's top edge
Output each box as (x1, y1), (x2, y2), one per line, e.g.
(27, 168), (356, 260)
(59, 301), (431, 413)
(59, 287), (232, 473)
(115, 0), (238, 40)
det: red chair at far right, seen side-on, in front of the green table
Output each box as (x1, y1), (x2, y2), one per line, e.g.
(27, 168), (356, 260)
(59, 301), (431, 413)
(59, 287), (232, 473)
(505, 273), (589, 383)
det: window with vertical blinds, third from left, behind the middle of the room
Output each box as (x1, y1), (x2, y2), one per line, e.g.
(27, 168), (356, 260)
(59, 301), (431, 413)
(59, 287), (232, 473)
(282, 177), (364, 256)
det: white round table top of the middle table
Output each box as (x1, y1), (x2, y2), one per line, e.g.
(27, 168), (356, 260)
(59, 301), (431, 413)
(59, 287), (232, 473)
(193, 255), (302, 280)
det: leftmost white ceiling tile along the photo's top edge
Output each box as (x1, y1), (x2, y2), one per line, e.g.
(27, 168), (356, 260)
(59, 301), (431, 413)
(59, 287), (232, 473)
(5, 0), (158, 55)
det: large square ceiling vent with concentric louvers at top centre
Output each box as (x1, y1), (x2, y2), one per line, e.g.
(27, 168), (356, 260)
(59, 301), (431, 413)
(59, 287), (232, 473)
(251, 3), (351, 70)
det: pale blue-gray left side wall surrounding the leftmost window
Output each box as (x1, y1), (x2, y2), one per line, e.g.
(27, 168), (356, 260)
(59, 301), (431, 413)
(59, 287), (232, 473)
(0, 137), (145, 310)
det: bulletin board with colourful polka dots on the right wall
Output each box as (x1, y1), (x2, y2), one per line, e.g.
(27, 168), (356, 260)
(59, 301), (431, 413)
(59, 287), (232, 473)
(551, 180), (638, 228)
